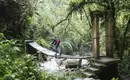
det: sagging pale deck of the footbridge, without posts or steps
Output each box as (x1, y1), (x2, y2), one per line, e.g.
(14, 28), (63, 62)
(26, 40), (92, 59)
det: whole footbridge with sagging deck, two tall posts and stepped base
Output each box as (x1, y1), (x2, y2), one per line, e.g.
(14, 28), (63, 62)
(26, 10), (121, 80)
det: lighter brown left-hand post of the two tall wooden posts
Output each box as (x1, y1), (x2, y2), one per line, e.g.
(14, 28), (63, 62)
(91, 11), (100, 59)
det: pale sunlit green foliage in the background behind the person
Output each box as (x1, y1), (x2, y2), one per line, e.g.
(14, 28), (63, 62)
(34, 0), (92, 54)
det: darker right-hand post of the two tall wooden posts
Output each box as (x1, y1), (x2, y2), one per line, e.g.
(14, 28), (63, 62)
(106, 10), (113, 57)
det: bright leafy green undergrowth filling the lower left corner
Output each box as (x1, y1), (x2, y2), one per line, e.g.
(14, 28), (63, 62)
(0, 40), (41, 80)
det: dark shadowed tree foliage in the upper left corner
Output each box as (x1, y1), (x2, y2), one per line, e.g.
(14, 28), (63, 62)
(0, 0), (37, 39)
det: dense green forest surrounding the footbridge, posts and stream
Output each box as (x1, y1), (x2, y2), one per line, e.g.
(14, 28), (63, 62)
(0, 0), (130, 80)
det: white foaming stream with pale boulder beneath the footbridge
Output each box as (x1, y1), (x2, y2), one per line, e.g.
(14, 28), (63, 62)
(40, 57), (88, 73)
